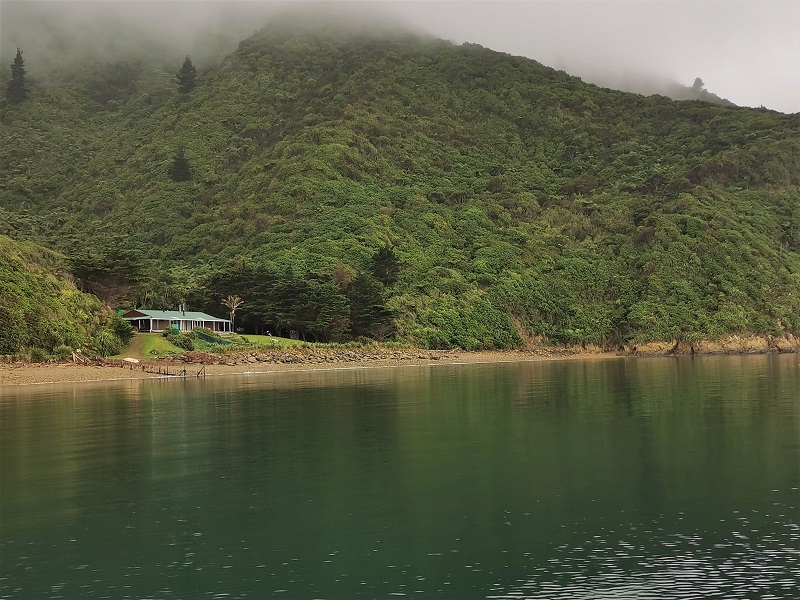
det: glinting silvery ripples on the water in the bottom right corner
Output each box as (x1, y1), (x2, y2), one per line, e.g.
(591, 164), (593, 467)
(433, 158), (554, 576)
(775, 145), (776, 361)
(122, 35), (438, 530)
(486, 506), (800, 600)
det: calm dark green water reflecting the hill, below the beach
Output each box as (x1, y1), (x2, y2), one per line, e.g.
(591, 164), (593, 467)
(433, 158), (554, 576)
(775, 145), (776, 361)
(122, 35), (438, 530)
(0, 356), (800, 600)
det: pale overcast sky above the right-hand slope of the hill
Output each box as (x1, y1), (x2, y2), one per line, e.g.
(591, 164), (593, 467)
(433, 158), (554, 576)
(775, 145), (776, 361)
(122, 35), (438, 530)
(0, 0), (800, 112)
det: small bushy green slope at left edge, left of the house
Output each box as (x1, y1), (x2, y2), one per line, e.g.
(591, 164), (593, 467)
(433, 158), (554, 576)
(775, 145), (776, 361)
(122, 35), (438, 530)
(0, 236), (131, 360)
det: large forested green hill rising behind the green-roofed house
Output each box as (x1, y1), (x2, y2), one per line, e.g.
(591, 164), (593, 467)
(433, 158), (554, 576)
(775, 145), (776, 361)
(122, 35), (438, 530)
(0, 15), (800, 349)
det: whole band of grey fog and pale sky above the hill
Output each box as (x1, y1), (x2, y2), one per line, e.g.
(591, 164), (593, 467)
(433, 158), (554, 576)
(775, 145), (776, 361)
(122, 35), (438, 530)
(0, 0), (800, 112)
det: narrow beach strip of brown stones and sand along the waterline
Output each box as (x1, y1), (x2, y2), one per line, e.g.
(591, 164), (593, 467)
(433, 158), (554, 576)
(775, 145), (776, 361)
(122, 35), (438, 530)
(0, 336), (800, 386)
